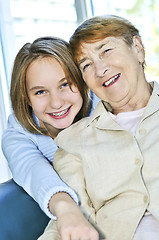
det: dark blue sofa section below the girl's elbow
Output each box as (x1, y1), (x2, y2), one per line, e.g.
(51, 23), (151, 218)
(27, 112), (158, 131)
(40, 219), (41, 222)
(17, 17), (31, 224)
(0, 179), (50, 240)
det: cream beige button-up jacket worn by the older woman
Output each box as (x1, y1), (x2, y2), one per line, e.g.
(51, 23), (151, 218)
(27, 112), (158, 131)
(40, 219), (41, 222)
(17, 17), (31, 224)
(39, 83), (159, 240)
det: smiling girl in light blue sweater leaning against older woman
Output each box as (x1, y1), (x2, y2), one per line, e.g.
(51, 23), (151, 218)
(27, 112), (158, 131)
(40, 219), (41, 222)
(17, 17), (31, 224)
(2, 37), (98, 239)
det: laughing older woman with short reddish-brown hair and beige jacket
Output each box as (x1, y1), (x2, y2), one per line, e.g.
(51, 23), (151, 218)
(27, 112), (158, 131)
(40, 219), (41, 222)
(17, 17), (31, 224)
(39, 16), (159, 240)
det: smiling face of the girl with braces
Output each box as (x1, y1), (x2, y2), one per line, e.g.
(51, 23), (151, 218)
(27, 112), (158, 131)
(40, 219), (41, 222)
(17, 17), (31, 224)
(26, 57), (83, 135)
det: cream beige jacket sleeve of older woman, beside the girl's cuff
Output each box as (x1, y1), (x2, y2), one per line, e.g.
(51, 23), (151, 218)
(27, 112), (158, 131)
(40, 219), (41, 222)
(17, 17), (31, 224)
(53, 148), (95, 224)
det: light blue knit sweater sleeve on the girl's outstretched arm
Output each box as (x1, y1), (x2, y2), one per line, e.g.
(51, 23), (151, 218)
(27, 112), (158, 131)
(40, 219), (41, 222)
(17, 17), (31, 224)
(2, 113), (78, 218)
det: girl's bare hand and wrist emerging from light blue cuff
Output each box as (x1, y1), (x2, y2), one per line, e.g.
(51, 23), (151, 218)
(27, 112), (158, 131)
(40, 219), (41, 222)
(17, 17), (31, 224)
(49, 192), (99, 240)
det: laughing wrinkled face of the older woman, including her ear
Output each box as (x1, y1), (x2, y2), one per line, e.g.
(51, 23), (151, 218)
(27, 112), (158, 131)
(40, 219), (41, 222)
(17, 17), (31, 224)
(78, 37), (144, 111)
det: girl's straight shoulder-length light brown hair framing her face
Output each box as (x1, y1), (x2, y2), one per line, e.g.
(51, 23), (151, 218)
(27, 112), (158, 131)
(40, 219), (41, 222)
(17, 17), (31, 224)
(10, 37), (91, 134)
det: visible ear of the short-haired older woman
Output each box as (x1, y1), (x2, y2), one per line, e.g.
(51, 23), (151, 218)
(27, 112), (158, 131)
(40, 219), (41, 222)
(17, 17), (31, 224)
(133, 36), (145, 63)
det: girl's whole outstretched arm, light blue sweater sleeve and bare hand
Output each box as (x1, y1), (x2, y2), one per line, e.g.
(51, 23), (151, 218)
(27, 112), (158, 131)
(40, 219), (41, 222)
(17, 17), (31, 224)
(2, 115), (100, 240)
